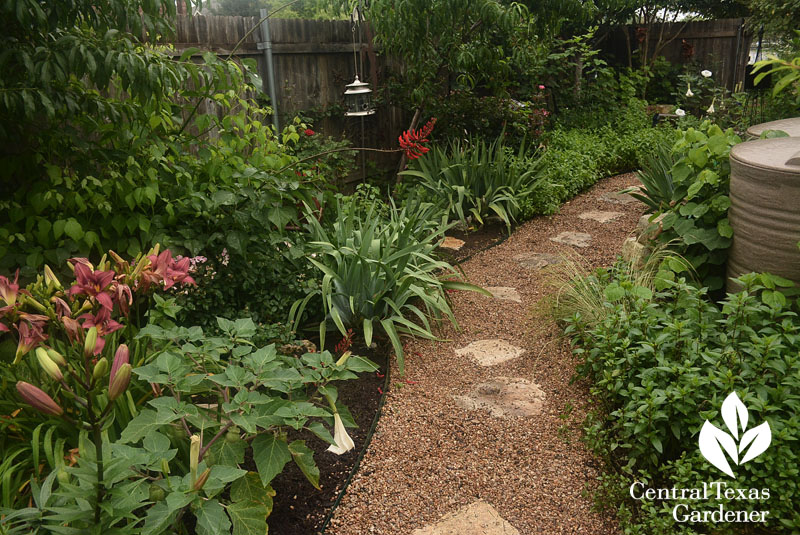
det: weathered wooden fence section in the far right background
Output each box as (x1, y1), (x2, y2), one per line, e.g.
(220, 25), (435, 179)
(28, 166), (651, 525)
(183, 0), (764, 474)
(601, 19), (753, 91)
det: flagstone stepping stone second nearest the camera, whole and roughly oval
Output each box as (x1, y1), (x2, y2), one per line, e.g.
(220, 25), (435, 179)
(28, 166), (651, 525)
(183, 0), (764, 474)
(455, 377), (545, 418)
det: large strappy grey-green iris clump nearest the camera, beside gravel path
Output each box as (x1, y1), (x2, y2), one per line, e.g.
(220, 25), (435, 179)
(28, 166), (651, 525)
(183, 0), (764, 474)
(289, 198), (487, 372)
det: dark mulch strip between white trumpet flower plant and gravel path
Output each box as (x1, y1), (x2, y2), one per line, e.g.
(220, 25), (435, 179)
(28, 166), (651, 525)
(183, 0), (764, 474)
(268, 346), (389, 535)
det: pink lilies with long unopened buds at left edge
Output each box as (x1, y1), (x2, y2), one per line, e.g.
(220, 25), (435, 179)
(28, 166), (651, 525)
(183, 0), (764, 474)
(0, 250), (194, 510)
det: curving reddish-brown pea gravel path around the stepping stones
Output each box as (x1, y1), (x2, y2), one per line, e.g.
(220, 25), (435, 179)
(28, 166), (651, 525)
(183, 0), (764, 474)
(327, 174), (643, 535)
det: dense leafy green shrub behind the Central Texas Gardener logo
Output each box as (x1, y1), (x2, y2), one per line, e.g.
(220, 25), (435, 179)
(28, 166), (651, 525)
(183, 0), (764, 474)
(566, 265), (800, 534)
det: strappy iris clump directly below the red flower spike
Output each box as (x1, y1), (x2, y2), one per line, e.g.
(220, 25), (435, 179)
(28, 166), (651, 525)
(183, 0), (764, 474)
(400, 136), (540, 232)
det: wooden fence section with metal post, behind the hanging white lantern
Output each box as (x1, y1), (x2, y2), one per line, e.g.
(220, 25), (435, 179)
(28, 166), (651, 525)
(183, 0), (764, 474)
(163, 15), (408, 170)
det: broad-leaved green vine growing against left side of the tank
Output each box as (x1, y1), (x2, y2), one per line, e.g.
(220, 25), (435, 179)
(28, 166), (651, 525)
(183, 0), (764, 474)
(657, 121), (741, 290)
